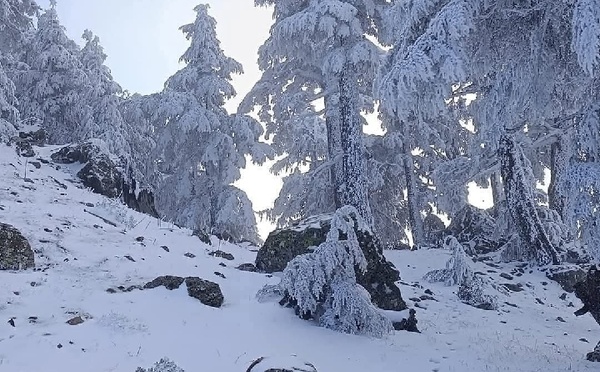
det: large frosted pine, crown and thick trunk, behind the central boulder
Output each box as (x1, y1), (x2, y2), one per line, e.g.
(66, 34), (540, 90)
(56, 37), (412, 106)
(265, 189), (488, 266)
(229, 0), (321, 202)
(242, 0), (387, 228)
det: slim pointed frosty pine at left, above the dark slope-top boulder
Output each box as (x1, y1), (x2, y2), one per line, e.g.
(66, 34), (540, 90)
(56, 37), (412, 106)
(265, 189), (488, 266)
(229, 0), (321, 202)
(75, 30), (131, 161)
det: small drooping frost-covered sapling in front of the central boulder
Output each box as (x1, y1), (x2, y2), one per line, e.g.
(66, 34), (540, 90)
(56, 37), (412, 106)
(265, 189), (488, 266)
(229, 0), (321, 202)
(268, 206), (392, 337)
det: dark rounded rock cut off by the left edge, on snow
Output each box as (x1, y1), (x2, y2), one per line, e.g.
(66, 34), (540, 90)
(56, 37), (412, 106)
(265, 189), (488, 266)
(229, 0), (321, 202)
(0, 223), (35, 270)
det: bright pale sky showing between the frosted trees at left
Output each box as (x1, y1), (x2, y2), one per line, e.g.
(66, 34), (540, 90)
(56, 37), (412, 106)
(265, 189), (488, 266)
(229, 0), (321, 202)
(38, 0), (281, 239)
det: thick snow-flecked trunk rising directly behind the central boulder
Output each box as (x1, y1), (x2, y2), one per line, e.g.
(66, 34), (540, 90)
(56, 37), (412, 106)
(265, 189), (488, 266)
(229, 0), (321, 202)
(336, 63), (373, 227)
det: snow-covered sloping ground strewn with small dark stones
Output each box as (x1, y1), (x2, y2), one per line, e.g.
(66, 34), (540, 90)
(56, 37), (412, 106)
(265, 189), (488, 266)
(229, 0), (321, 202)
(0, 146), (600, 372)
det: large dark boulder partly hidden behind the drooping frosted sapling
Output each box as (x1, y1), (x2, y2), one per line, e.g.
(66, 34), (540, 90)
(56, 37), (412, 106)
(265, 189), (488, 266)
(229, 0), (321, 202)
(255, 214), (407, 311)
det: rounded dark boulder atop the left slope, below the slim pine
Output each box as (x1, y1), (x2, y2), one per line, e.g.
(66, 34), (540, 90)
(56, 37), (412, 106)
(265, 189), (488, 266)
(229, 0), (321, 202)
(77, 154), (123, 198)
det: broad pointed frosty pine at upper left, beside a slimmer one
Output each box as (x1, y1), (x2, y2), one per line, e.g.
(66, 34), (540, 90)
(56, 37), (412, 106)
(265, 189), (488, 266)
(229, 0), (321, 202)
(15, 1), (89, 144)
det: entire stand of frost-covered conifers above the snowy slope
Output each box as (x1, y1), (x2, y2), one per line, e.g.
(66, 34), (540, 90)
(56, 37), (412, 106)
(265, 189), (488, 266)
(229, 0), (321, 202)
(0, 0), (600, 366)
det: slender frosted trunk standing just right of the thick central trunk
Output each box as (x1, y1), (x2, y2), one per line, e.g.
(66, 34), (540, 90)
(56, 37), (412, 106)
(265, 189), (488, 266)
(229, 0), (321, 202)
(402, 148), (425, 248)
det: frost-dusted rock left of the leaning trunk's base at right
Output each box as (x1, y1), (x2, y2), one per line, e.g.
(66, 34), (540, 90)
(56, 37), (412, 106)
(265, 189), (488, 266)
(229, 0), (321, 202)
(447, 205), (504, 254)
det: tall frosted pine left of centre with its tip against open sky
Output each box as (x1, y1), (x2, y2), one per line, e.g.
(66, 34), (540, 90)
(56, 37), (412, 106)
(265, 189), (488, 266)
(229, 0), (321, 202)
(157, 5), (269, 242)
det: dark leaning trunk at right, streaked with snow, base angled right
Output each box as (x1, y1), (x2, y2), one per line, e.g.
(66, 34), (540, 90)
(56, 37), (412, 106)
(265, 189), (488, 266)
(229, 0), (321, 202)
(498, 135), (560, 265)
